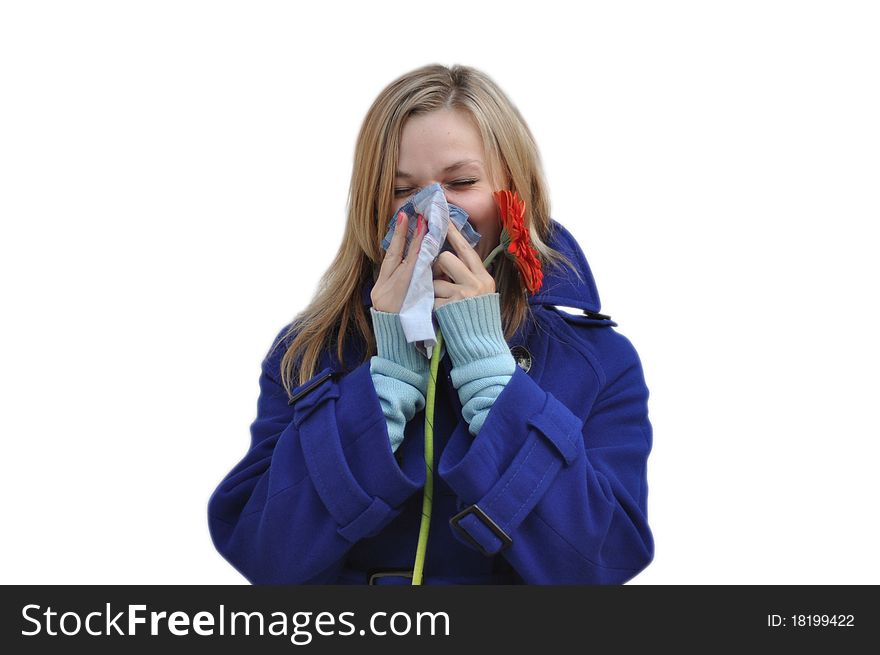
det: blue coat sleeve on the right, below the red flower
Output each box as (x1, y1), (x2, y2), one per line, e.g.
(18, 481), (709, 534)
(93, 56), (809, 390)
(438, 334), (654, 584)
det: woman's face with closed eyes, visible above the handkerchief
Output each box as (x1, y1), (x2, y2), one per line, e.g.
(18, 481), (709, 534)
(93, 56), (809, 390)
(393, 109), (502, 259)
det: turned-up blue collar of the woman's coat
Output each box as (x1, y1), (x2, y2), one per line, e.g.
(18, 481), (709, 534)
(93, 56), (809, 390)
(361, 218), (601, 313)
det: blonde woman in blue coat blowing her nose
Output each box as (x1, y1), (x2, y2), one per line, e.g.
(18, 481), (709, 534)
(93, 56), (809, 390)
(208, 65), (654, 584)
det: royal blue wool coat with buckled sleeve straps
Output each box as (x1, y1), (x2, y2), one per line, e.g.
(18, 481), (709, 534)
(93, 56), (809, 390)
(208, 221), (654, 584)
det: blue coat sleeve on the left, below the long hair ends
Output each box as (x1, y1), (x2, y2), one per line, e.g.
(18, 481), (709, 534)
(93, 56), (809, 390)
(208, 334), (424, 584)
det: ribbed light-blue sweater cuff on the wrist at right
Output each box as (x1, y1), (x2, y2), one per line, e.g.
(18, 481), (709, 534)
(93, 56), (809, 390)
(435, 292), (511, 366)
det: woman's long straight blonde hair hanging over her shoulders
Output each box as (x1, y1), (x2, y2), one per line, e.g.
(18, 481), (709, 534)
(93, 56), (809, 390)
(276, 64), (580, 395)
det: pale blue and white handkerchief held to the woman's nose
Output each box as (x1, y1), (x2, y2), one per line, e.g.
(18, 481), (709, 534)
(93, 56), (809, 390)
(382, 182), (480, 359)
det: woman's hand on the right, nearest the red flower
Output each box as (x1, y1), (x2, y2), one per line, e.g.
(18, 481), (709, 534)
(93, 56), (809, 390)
(431, 221), (495, 309)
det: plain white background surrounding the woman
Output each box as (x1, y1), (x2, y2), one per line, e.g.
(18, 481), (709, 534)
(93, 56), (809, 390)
(0, 0), (880, 584)
